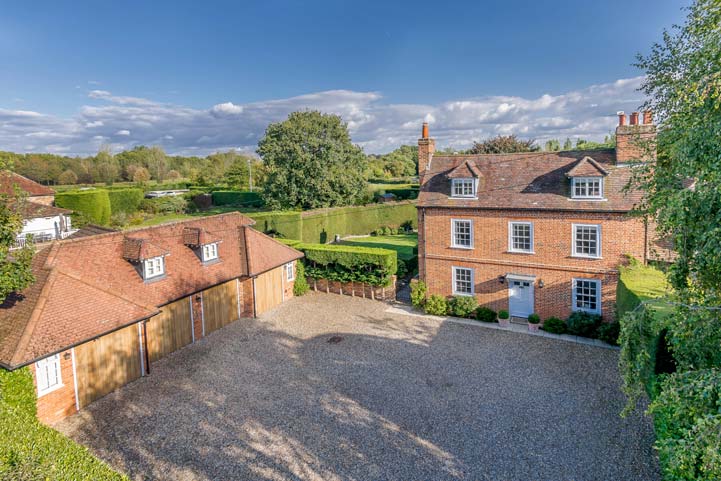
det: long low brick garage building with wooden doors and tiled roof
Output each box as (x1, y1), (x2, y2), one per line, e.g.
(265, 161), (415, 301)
(0, 213), (303, 423)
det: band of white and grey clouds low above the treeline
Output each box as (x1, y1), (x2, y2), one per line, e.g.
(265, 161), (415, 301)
(0, 77), (643, 155)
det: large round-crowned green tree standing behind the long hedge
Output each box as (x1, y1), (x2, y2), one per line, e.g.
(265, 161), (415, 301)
(257, 111), (366, 209)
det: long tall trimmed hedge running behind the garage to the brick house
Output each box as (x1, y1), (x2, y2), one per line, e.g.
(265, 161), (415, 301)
(245, 201), (418, 244)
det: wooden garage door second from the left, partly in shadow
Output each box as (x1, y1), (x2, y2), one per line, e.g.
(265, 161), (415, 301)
(146, 297), (193, 363)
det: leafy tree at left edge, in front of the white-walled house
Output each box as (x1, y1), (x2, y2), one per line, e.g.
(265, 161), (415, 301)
(0, 159), (35, 304)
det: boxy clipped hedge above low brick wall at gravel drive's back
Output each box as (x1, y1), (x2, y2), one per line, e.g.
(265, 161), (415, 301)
(286, 242), (398, 287)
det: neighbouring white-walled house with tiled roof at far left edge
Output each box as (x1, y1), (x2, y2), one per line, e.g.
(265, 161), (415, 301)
(0, 171), (75, 247)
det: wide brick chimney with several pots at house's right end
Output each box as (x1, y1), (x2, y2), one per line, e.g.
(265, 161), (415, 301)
(616, 110), (656, 164)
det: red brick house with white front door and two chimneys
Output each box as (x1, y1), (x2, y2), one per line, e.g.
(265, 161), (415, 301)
(418, 112), (656, 321)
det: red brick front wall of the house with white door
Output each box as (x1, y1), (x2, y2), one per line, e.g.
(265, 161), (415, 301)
(418, 208), (645, 320)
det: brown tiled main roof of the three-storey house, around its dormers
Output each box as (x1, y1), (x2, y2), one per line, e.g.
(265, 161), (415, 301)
(418, 149), (641, 212)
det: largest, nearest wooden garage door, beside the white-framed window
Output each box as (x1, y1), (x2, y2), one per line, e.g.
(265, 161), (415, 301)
(75, 324), (141, 408)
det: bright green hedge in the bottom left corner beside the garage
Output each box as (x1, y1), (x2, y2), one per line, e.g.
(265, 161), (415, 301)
(0, 368), (127, 481)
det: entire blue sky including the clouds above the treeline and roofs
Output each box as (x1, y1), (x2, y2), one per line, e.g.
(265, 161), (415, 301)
(0, 0), (688, 154)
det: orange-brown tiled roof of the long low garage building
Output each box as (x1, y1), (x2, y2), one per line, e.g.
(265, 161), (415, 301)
(0, 212), (302, 368)
